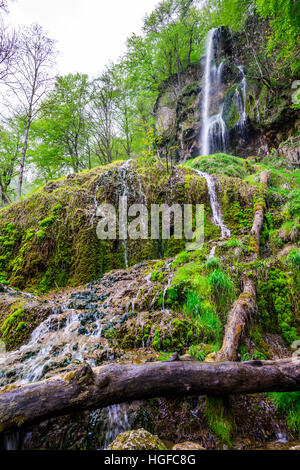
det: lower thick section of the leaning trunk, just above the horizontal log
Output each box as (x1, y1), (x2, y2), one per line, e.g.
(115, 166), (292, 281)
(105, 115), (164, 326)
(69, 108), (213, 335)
(214, 276), (257, 361)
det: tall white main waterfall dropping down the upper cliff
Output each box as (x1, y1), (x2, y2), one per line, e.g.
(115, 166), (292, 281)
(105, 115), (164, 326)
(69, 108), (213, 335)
(201, 29), (229, 156)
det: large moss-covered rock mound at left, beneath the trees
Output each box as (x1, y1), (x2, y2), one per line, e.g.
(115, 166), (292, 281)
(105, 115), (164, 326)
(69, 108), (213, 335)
(0, 158), (208, 293)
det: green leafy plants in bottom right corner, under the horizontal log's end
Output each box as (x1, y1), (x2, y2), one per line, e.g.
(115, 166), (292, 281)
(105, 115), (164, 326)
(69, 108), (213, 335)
(269, 392), (300, 435)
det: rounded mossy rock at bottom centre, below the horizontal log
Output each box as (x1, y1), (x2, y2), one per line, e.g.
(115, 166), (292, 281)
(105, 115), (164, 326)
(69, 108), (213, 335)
(107, 428), (167, 450)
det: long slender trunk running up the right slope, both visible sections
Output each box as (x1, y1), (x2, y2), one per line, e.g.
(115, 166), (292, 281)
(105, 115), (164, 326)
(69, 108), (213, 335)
(212, 170), (270, 361)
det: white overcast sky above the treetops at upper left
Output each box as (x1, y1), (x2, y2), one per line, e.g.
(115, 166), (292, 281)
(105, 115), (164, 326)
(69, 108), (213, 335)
(7, 0), (159, 76)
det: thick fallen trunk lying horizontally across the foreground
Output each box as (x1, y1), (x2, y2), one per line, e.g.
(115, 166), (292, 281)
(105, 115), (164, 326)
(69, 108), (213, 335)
(0, 358), (300, 432)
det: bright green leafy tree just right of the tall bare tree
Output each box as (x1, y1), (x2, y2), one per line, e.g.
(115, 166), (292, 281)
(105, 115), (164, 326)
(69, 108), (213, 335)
(32, 74), (90, 181)
